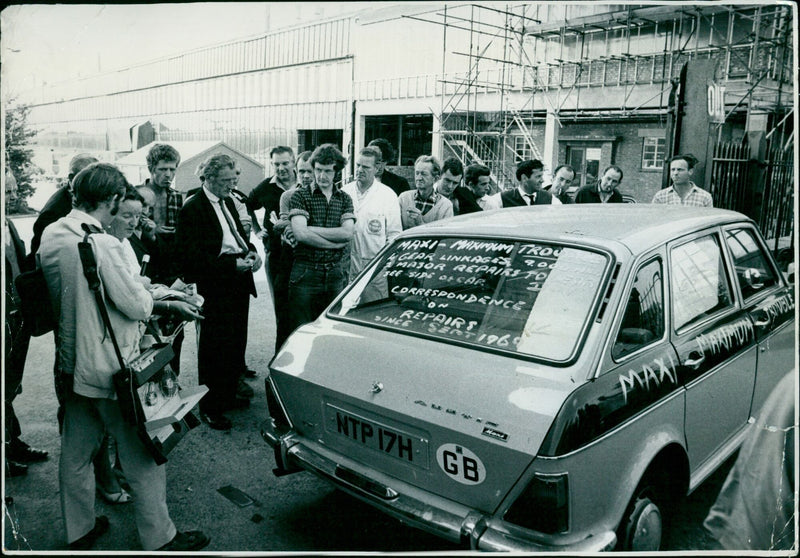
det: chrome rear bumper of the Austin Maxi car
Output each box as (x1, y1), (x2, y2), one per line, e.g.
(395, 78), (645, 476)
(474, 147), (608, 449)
(261, 420), (616, 553)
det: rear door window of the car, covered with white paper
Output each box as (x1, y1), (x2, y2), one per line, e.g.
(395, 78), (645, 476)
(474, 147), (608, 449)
(670, 235), (731, 330)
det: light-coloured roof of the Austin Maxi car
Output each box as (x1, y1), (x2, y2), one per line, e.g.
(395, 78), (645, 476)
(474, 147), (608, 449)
(402, 207), (750, 254)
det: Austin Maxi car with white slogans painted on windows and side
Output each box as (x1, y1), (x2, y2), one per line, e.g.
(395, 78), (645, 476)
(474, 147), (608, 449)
(262, 204), (796, 552)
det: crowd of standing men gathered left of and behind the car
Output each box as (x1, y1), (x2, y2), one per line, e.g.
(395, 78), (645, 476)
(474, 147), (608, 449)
(5, 139), (712, 551)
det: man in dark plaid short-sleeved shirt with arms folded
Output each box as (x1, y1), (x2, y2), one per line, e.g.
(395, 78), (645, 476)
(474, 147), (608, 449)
(289, 143), (356, 330)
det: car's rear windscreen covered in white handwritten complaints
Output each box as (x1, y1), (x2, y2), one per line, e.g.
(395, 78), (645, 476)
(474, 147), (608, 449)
(328, 238), (609, 361)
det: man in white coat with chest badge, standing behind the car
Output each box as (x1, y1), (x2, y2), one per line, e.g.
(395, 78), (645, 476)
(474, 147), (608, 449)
(342, 147), (403, 296)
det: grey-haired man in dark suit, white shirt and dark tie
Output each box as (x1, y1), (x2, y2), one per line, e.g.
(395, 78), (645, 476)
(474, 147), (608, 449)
(176, 154), (261, 430)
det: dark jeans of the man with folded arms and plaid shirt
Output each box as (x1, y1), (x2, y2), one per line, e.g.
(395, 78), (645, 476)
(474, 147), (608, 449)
(289, 260), (347, 330)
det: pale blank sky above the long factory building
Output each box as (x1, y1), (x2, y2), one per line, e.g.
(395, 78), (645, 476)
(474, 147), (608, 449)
(0, 2), (365, 99)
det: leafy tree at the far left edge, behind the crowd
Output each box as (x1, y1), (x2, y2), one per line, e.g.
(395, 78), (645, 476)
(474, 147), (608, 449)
(6, 99), (42, 213)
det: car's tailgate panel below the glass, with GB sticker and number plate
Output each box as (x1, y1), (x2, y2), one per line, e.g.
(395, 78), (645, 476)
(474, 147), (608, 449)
(270, 318), (574, 511)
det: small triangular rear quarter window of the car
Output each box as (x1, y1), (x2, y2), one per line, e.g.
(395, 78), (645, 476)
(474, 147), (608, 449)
(611, 260), (664, 359)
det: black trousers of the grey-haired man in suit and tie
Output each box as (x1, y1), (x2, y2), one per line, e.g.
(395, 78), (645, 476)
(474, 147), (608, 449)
(197, 281), (250, 413)
